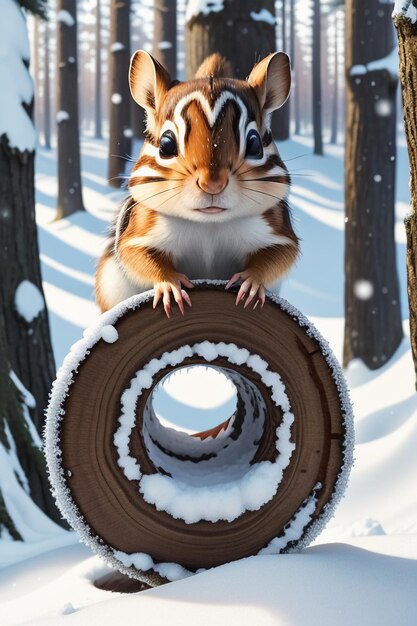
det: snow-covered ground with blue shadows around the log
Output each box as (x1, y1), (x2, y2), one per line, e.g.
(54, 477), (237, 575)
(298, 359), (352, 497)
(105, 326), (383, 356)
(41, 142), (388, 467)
(0, 138), (417, 626)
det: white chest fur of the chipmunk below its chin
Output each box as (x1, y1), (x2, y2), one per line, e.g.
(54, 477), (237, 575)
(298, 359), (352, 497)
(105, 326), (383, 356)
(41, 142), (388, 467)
(125, 214), (290, 279)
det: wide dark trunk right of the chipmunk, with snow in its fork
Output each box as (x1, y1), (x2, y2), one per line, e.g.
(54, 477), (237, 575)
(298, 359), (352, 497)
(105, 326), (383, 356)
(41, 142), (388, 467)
(343, 0), (403, 369)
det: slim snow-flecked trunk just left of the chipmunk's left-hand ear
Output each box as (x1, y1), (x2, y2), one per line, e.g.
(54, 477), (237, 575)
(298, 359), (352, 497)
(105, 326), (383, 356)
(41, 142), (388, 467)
(108, 0), (132, 187)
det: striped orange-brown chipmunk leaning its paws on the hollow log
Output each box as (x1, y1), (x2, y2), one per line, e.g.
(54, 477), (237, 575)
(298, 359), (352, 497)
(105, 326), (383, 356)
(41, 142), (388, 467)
(96, 50), (299, 317)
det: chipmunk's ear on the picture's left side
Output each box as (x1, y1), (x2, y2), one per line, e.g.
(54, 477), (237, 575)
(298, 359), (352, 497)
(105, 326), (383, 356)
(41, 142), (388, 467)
(129, 50), (172, 127)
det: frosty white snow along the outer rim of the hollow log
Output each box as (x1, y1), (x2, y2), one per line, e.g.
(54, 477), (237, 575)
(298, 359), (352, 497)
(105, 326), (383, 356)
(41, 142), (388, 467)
(44, 280), (354, 586)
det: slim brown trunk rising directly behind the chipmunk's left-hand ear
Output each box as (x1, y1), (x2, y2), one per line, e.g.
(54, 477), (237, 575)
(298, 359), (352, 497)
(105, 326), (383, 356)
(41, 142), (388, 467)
(152, 0), (177, 79)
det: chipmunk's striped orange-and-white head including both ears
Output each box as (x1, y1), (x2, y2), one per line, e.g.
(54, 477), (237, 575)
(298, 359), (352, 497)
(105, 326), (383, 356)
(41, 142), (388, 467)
(129, 51), (291, 222)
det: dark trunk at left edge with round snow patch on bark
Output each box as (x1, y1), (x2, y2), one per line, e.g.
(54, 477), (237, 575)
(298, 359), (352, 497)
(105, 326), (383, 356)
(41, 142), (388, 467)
(0, 136), (55, 433)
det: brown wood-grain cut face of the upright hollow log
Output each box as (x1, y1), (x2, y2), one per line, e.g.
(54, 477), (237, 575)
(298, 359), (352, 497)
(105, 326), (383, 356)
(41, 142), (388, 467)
(61, 286), (344, 569)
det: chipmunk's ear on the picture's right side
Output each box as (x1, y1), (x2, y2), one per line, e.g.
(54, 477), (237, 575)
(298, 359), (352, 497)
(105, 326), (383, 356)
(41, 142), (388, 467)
(248, 52), (291, 113)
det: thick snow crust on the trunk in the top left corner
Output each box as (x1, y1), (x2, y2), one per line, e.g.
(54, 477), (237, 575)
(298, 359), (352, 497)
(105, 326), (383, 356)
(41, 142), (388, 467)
(0, 0), (36, 152)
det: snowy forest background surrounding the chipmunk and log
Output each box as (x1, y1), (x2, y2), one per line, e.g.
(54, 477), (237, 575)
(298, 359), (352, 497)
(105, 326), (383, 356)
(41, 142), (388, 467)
(0, 0), (417, 626)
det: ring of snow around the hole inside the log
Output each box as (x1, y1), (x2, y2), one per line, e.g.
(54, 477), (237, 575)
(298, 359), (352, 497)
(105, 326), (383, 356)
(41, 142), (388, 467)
(114, 341), (295, 524)
